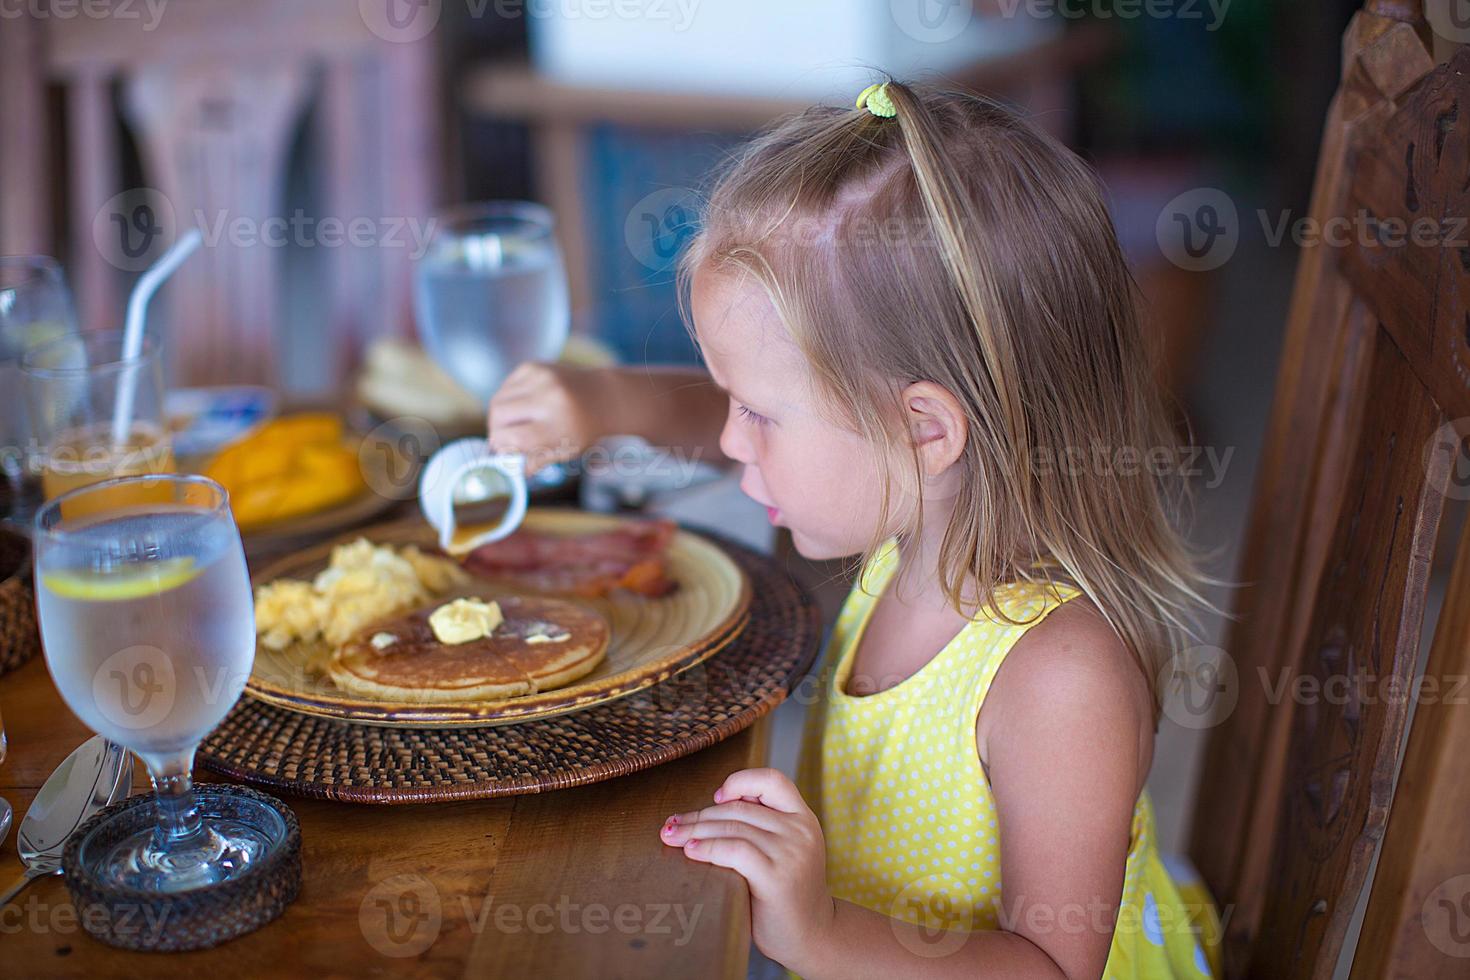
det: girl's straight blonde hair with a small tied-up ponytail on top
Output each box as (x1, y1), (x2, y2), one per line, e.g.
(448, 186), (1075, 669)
(679, 82), (1220, 714)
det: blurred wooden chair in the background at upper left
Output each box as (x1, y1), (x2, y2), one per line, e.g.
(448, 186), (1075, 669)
(0, 0), (442, 388)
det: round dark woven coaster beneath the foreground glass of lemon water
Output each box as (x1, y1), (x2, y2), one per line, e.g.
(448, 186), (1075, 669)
(62, 783), (301, 952)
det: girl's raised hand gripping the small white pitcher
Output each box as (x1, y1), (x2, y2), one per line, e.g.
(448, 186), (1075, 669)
(485, 361), (619, 473)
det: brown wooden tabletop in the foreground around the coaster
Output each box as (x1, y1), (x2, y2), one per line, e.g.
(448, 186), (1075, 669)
(0, 657), (769, 979)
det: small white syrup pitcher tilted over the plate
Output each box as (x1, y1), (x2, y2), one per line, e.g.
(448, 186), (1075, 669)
(419, 438), (528, 555)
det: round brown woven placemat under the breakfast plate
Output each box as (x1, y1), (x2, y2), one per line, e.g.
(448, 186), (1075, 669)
(198, 532), (822, 804)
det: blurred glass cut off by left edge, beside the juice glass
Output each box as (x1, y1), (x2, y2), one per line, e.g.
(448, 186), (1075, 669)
(0, 256), (76, 519)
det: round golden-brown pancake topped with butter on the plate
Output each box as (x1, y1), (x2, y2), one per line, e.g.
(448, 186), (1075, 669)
(329, 595), (609, 702)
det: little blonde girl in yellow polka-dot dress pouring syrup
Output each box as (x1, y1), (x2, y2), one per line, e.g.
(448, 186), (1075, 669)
(490, 82), (1219, 977)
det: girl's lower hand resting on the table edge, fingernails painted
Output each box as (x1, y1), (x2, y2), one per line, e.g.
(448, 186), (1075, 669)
(660, 768), (833, 968)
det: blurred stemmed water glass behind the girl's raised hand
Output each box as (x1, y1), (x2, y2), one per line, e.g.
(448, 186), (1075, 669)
(413, 201), (570, 404)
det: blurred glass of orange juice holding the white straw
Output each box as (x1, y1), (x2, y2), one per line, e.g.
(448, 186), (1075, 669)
(21, 331), (173, 511)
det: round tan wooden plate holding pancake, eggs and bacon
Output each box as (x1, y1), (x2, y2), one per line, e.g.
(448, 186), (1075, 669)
(245, 508), (751, 729)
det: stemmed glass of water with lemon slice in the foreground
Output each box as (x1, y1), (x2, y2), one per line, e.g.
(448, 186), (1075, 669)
(35, 476), (276, 892)
